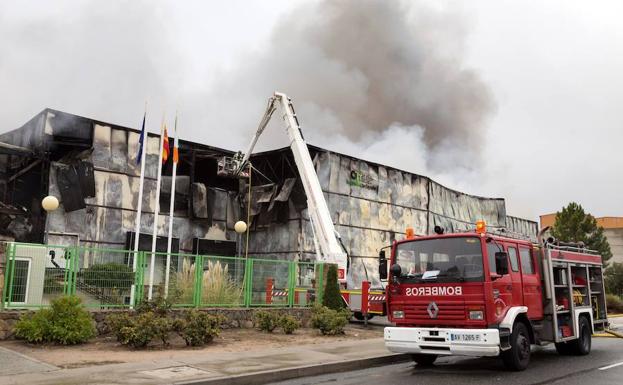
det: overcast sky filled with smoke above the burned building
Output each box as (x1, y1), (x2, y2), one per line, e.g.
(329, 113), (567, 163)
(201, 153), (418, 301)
(0, 0), (623, 220)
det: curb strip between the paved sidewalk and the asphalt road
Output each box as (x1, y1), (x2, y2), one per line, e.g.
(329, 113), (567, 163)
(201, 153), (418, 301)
(178, 354), (411, 385)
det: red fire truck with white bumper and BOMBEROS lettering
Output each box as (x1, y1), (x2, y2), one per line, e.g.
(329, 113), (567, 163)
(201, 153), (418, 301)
(379, 221), (608, 370)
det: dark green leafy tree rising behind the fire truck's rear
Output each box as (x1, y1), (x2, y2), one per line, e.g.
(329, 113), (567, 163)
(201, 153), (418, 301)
(552, 202), (612, 266)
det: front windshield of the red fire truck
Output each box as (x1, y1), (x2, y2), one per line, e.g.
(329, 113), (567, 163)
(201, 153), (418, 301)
(396, 237), (484, 282)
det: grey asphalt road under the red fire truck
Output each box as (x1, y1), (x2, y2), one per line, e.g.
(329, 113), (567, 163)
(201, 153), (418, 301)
(274, 338), (623, 385)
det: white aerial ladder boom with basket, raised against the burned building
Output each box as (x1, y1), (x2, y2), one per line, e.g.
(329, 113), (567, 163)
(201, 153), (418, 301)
(219, 92), (352, 283)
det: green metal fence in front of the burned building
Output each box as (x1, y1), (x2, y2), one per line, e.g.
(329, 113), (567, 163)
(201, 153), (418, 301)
(2, 243), (324, 308)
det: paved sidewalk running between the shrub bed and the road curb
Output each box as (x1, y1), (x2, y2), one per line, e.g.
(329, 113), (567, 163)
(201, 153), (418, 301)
(0, 338), (406, 384)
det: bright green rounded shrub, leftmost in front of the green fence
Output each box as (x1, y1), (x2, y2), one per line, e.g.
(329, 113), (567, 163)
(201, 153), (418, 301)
(15, 296), (95, 345)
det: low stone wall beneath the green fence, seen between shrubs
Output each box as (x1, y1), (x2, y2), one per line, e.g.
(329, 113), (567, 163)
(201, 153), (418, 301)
(0, 308), (311, 340)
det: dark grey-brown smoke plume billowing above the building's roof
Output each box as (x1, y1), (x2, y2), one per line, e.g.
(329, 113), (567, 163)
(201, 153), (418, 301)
(205, 0), (494, 171)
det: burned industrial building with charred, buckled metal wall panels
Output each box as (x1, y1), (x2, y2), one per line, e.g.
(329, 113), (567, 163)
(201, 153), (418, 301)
(0, 109), (537, 284)
